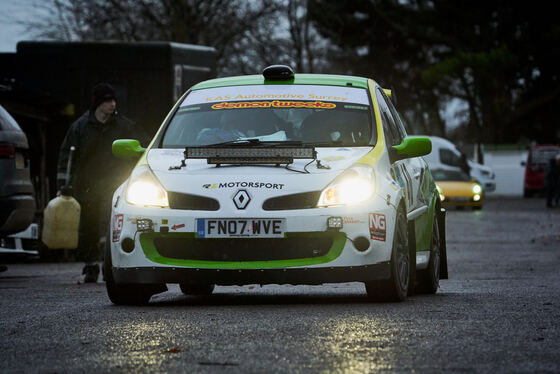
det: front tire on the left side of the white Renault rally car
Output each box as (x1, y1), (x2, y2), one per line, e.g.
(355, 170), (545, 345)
(103, 237), (167, 305)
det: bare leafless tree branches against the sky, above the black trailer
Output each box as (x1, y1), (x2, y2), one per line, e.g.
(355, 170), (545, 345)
(28, 0), (324, 75)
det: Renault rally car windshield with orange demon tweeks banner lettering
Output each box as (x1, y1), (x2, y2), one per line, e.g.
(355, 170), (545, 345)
(161, 85), (376, 148)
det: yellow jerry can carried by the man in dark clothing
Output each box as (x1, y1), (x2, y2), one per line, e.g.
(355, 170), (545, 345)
(41, 195), (81, 249)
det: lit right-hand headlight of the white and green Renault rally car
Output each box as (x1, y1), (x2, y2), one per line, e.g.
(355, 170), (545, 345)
(317, 165), (375, 206)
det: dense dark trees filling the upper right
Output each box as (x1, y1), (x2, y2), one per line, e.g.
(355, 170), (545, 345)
(309, 0), (560, 143)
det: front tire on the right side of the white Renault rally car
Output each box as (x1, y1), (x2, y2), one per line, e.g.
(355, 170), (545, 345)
(365, 209), (410, 302)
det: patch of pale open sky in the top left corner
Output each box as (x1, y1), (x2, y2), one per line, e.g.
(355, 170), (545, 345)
(0, 0), (44, 52)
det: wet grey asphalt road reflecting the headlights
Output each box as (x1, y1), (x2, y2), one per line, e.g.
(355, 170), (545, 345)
(0, 199), (560, 373)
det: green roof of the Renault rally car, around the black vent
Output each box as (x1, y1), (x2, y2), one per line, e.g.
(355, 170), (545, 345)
(191, 74), (368, 90)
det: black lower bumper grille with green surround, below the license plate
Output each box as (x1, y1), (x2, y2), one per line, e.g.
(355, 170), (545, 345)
(154, 235), (334, 261)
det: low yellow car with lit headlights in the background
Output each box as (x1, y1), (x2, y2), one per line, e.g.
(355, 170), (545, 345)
(432, 169), (484, 210)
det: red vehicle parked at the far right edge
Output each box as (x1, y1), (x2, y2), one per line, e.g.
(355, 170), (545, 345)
(521, 144), (560, 197)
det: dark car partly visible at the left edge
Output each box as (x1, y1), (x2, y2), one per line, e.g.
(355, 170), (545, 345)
(0, 105), (35, 237)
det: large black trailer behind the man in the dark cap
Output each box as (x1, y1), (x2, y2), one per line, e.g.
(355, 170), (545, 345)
(0, 41), (216, 211)
